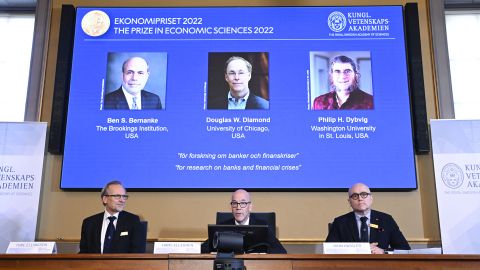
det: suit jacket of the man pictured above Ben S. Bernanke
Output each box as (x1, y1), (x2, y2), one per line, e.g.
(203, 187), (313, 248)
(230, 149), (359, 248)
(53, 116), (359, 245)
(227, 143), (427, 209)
(103, 87), (162, 110)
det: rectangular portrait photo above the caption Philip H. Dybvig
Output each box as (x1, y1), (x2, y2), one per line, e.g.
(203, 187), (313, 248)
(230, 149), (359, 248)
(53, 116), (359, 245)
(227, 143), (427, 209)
(310, 51), (374, 110)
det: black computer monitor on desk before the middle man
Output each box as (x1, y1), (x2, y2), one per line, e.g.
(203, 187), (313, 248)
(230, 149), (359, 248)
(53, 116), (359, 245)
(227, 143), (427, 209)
(208, 224), (270, 253)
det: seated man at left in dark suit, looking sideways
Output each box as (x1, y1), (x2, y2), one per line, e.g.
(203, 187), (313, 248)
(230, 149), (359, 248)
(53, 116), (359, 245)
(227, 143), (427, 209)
(80, 181), (146, 253)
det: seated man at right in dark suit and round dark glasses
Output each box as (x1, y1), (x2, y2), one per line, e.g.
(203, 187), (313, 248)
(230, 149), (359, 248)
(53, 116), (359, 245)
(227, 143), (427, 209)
(326, 183), (410, 254)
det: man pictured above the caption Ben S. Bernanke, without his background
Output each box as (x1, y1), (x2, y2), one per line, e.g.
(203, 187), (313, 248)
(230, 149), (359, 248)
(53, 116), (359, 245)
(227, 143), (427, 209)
(103, 57), (162, 110)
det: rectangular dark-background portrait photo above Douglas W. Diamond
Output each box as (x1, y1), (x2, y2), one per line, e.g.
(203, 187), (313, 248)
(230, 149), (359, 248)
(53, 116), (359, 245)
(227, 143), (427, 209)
(207, 53), (270, 110)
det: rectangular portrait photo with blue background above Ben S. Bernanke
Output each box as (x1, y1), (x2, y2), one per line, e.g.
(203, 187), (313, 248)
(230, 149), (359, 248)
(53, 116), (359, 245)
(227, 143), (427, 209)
(103, 53), (167, 110)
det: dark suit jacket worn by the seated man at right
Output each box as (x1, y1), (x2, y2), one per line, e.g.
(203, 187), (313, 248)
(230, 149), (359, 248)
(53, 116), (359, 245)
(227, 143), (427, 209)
(326, 210), (410, 250)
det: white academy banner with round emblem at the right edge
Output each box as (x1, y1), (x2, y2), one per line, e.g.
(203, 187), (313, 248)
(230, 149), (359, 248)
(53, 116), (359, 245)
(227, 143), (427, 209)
(430, 120), (480, 254)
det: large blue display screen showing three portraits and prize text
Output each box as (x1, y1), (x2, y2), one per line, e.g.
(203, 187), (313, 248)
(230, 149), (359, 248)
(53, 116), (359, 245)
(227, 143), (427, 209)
(61, 6), (417, 190)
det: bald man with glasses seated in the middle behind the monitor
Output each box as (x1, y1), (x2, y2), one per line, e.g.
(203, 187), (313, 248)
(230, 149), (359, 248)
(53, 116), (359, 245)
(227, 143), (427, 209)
(202, 189), (287, 254)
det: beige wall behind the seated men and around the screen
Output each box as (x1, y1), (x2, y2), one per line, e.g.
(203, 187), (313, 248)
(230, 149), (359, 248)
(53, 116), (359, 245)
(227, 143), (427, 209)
(37, 0), (440, 242)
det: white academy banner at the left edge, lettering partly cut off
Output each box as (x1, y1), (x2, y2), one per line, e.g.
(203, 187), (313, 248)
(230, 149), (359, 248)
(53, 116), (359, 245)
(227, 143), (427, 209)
(0, 122), (47, 253)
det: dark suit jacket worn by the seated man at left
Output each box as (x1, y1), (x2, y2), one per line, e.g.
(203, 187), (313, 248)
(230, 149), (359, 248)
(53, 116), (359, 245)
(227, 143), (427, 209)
(80, 211), (147, 253)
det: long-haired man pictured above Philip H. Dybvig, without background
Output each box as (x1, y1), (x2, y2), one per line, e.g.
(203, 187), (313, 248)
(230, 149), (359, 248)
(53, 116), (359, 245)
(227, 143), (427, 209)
(313, 55), (373, 110)
